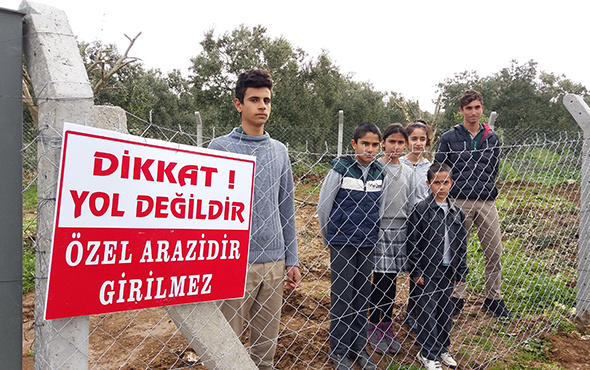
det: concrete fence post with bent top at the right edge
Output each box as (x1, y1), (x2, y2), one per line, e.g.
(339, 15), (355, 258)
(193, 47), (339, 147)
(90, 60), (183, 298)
(563, 94), (590, 322)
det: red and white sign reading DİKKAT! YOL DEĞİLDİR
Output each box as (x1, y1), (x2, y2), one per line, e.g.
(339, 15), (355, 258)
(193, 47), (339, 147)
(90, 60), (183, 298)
(45, 123), (255, 319)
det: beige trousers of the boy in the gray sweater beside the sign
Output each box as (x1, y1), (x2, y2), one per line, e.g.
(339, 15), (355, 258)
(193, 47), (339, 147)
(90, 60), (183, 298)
(218, 260), (285, 369)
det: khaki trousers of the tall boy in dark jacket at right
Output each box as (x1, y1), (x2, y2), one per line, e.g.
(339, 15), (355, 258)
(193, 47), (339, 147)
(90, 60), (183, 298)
(453, 199), (502, 299)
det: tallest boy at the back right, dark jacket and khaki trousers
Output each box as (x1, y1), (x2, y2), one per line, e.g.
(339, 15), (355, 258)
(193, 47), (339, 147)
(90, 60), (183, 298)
(434, 90), (512, 318)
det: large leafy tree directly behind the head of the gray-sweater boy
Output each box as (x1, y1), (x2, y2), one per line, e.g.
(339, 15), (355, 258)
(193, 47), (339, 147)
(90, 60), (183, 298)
(188, 25), (410, 153)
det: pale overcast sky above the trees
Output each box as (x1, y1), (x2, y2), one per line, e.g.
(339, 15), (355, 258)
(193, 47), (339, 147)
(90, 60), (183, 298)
(0, 0), (590, 112)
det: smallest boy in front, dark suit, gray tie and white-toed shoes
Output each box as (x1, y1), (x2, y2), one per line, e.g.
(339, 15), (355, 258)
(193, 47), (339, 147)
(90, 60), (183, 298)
(407, 162), (467, 370)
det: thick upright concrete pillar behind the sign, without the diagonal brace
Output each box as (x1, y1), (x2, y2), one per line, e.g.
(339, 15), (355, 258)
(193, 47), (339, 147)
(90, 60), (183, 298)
(20, 0), (94, 370)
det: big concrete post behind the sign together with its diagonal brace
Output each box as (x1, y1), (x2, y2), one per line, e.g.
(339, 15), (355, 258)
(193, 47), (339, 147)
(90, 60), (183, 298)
(18, 0), (256, 370)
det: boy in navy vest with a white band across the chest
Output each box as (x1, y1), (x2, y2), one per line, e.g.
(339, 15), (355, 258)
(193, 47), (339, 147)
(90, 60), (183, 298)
(318, 122), (384, 370)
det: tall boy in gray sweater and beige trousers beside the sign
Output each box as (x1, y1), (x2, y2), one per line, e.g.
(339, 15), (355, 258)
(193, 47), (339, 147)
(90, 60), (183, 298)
(209, 69), (301, 369)
